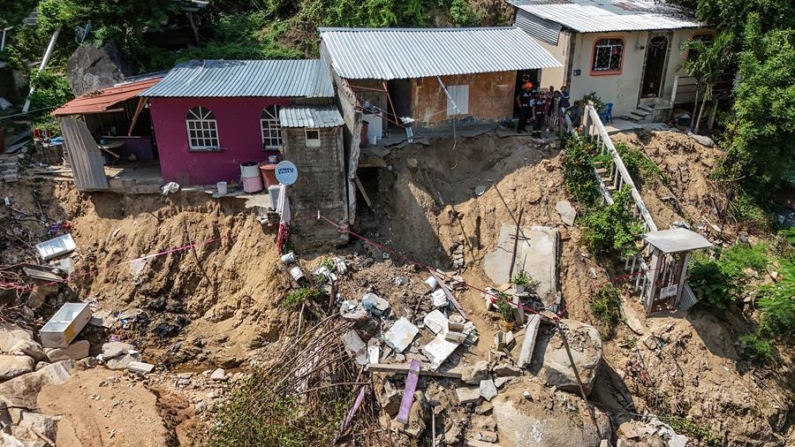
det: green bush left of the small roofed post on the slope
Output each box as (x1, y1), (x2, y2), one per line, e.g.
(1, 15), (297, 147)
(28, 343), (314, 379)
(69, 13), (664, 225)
(583, 186), (643, 256)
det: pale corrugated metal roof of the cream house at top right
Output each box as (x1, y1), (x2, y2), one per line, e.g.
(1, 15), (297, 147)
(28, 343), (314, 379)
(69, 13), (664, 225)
(508, 0), (702, 33)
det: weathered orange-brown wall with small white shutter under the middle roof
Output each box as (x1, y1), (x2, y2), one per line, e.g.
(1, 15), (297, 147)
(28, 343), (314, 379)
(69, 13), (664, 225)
(411, 71), (516, 125)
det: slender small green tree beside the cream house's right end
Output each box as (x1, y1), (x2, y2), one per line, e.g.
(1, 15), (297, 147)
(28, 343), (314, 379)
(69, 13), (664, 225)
(682, 32), (734, 133)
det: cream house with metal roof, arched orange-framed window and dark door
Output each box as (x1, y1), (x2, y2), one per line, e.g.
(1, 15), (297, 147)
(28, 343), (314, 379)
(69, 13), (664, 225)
(509, 0), (714, 120)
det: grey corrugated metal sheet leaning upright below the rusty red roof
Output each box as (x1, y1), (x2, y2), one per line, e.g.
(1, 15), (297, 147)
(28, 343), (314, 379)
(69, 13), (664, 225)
(58, 116), (108, 191)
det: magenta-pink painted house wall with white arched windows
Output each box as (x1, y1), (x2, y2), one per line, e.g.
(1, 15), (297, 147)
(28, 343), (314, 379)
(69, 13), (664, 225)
(149, 98), (291, 186)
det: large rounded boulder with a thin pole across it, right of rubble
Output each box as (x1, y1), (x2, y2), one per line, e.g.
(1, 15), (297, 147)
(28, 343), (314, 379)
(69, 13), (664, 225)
(531, 320), (602, 394)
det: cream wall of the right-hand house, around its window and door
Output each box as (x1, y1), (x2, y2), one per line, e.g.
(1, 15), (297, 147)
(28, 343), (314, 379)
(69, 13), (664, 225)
(570, 29), (709, 117)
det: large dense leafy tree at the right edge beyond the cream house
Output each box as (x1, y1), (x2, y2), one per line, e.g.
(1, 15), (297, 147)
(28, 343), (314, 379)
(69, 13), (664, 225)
(718, 14), (795, 199)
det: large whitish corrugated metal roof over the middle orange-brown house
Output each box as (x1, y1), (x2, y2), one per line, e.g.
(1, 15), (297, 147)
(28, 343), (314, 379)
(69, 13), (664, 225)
(320, 27), (561, 80)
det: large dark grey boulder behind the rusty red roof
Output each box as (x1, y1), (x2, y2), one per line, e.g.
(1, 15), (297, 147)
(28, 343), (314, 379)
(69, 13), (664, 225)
(66, 43), (130, 96)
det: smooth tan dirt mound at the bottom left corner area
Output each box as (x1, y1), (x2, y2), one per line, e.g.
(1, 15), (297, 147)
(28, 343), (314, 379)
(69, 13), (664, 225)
(38, 368), (169, 447)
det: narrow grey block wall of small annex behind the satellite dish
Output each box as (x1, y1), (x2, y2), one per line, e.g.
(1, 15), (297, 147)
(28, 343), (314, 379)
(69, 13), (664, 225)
(282, 127), (348, 248)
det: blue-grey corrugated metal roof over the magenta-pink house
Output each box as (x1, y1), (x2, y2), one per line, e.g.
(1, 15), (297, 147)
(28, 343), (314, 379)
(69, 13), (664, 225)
(141, 59), (334, 98)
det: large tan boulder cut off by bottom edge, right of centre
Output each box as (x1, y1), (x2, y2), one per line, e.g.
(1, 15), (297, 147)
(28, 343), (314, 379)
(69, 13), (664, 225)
(491, 393), (610, 447)
